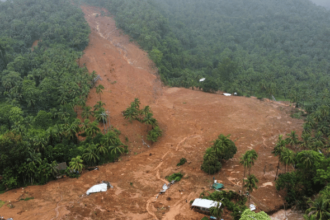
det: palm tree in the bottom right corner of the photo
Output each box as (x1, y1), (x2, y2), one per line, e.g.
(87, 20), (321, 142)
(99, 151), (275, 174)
(305, 196), (330, 220)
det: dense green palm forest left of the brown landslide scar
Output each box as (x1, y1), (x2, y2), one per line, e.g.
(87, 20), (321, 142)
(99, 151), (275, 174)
(0, 0), (129, 192)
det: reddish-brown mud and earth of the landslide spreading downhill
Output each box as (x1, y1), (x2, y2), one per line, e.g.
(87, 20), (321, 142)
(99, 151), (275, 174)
(0, 6), (303, 220)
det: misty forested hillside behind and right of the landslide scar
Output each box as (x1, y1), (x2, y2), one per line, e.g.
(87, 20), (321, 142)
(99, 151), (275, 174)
(87, 0), (330, 111)
